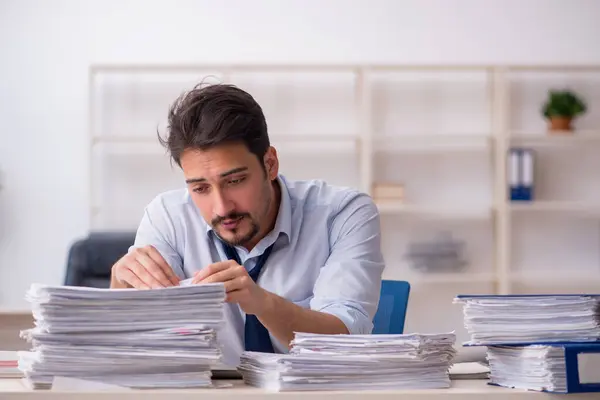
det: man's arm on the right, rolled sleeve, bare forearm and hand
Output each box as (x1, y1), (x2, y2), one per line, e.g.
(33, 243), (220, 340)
(194, 191), (384, 346)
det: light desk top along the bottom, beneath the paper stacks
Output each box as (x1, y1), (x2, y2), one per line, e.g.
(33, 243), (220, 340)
(0, 379), (600, 400)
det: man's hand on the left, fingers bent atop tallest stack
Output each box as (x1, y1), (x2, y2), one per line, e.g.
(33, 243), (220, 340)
(111, 246), (179, 289)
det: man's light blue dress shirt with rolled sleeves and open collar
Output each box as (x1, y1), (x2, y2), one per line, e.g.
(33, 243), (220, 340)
(133, 175), (384, 367)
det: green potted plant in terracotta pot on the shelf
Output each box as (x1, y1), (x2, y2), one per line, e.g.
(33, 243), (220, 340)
(542, 90), (587, 132)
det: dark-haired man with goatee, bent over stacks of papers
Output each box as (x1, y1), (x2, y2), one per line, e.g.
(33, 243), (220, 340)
(111, 85), (384, 366)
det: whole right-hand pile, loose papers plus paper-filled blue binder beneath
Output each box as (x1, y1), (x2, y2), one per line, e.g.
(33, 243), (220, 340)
(455, 295), (600, 393)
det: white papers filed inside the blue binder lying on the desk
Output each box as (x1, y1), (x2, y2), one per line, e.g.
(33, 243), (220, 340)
(487, 345), (567, 392)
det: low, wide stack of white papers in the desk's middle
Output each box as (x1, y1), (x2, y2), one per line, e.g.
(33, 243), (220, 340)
(239, 333), (456, 391)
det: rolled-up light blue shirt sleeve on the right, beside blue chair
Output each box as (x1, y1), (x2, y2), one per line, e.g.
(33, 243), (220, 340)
(311, 194), (385, 334)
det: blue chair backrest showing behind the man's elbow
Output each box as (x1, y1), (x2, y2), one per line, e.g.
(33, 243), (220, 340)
(373, 280), (410, 334)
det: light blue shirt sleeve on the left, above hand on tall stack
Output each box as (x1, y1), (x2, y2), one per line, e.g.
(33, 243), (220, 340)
(129, 196), (185, 279)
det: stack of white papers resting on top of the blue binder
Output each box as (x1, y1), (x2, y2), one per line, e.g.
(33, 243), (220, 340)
(455, 295), (600, 345)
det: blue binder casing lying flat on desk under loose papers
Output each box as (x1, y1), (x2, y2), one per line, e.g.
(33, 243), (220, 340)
(490, 342), (600, 393)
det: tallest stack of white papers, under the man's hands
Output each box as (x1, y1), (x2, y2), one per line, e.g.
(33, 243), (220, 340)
(19, 284), (225, 388)
